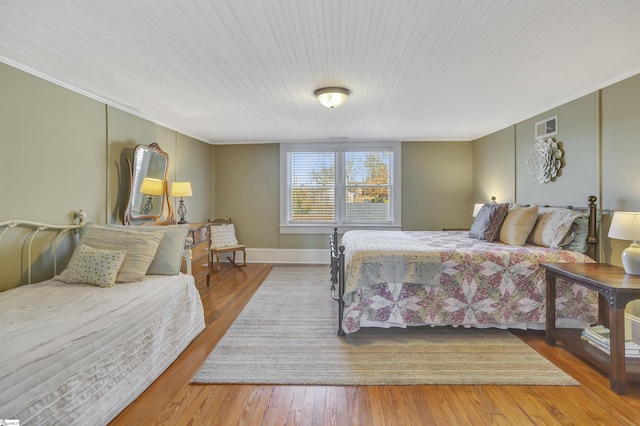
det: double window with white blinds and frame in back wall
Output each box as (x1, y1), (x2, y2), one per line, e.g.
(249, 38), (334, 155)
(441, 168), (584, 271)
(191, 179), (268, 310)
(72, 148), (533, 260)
(280, 142), (400, 233)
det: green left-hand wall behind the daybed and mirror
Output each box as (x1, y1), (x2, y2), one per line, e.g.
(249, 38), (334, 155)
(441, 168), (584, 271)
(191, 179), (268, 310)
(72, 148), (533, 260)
(0, 63), (213, 290)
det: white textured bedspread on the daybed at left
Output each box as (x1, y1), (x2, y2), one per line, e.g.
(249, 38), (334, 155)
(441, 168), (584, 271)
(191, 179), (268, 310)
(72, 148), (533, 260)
(0, 274), (205, 426)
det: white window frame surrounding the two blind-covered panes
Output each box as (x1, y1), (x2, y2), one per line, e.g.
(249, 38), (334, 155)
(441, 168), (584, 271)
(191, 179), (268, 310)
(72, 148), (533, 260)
(280, 141), (402, 234)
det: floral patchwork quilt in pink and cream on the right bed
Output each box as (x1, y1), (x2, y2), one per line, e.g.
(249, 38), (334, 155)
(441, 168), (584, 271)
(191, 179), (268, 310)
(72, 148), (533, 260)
(341, 231), (598, 333)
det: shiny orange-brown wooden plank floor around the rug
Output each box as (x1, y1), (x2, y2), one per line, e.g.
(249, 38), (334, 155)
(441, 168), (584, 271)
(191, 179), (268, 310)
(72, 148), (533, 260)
(112, 264), (640, 425)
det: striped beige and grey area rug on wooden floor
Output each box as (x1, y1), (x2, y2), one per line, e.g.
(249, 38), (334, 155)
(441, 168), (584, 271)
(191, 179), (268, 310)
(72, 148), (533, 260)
(192, 266), (578, 386)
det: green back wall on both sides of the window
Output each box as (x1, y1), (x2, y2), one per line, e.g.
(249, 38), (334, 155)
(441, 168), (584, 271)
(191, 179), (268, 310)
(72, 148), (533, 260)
(214, 142), (473, 249)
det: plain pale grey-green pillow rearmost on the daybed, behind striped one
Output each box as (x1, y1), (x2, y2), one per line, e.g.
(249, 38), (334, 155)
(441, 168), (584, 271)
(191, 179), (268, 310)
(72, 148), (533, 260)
(107, 223), (189, 275)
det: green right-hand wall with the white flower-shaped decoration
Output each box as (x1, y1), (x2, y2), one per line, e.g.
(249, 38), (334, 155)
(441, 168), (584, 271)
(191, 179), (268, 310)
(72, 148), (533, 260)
(473, 74), (640, 265)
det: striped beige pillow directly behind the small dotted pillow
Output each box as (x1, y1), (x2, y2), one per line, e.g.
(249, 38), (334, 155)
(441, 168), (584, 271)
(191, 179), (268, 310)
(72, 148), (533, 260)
(80, 223), (163, 283)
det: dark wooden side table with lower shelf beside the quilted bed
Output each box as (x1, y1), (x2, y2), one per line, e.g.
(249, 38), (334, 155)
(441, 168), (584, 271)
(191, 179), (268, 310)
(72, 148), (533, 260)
(540, 263), (640, 395)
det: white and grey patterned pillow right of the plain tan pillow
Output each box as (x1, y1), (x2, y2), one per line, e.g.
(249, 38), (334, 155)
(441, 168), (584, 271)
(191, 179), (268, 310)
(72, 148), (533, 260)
(527, 207), (584, 248)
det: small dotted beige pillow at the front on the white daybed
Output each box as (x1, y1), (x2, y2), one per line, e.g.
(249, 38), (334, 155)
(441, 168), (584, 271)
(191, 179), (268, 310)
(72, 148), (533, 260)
(56, 244), (127, 287)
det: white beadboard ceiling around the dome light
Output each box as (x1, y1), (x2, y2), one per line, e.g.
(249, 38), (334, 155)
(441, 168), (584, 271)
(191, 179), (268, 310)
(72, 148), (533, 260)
(0, 0), (640, 143)
